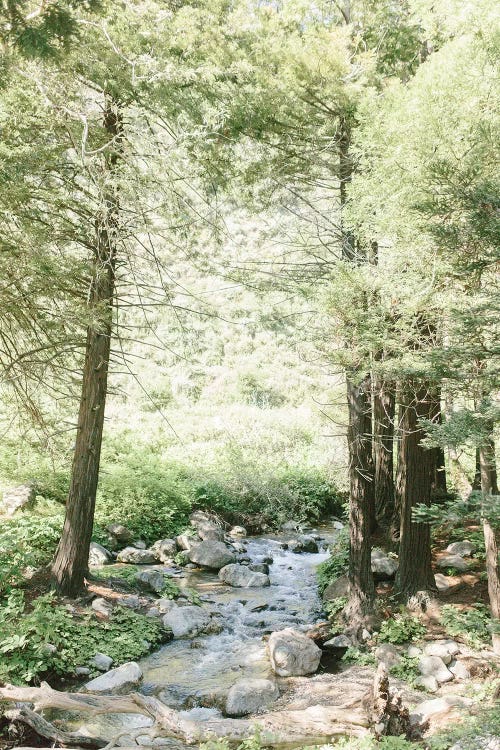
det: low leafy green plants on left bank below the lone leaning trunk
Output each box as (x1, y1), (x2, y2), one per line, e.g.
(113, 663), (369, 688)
(0, 591), (166, 684)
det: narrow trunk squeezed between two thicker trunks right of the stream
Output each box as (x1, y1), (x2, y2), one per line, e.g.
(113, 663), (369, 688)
(373, 378), (396, 528)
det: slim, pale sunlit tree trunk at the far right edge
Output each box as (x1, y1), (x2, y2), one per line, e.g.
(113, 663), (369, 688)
(479, 432), (500, 654)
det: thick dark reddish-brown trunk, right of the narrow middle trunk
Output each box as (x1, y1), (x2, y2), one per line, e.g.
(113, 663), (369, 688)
(396, 383), (436, 606)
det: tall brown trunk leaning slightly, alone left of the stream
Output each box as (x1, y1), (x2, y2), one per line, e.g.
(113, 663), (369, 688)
(52, 98), (122, 597)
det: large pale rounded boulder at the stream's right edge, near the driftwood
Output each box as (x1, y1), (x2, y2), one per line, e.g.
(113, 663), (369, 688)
(268, 628), (321, 677)
